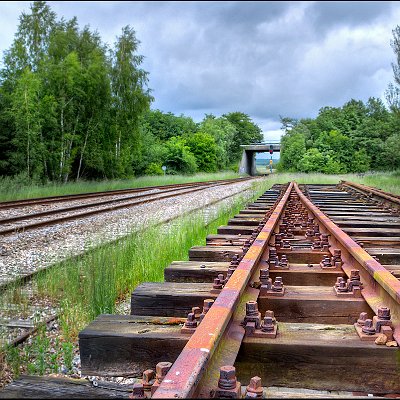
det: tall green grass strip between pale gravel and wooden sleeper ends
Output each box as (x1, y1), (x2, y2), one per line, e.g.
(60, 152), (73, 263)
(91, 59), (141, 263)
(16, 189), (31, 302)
(27, 180), (271, 340)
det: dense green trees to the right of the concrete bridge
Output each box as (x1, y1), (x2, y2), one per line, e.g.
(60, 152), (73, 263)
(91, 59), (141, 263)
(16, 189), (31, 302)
(278, 26), (400, 174)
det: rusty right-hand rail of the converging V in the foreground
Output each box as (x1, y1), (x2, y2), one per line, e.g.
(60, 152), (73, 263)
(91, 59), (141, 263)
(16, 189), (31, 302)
(294, 183), (400, 342)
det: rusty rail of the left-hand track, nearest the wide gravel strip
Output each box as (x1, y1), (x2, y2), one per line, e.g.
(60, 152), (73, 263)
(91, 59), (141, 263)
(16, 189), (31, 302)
(0, 182), (247, 235)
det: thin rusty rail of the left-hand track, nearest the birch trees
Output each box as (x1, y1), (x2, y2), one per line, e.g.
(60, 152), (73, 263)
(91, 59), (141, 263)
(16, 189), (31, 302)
(0, 177), (254, 210)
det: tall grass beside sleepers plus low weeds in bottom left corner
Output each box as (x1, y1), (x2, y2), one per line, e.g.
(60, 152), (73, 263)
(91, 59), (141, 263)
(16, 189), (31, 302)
(0, 180), (271, 377)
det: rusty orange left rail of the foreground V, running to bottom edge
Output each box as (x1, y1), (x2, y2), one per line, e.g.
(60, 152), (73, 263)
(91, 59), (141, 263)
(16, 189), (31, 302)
(154, 182), (293, 398)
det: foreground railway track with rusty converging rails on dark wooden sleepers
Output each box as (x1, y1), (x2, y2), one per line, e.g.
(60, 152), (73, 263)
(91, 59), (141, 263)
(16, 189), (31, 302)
(3, 182), (400, 398)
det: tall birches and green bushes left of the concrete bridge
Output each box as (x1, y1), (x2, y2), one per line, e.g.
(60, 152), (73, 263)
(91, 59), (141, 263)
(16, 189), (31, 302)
(0, 1), (262, 182)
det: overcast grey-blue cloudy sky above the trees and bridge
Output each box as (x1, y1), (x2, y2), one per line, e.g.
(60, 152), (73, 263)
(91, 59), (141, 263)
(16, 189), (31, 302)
(0, 1), (400, 139)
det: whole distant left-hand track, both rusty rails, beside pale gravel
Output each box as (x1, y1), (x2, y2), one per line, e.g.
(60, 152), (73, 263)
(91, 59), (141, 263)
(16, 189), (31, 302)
(0, 178), (251, 236)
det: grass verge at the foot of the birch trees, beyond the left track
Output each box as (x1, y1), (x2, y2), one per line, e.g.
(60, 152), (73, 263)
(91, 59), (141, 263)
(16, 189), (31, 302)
(0, 171), (239, 201)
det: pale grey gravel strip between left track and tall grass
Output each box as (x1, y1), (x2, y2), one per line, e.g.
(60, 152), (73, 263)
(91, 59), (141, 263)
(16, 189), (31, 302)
(0, 181), (260, 285)
